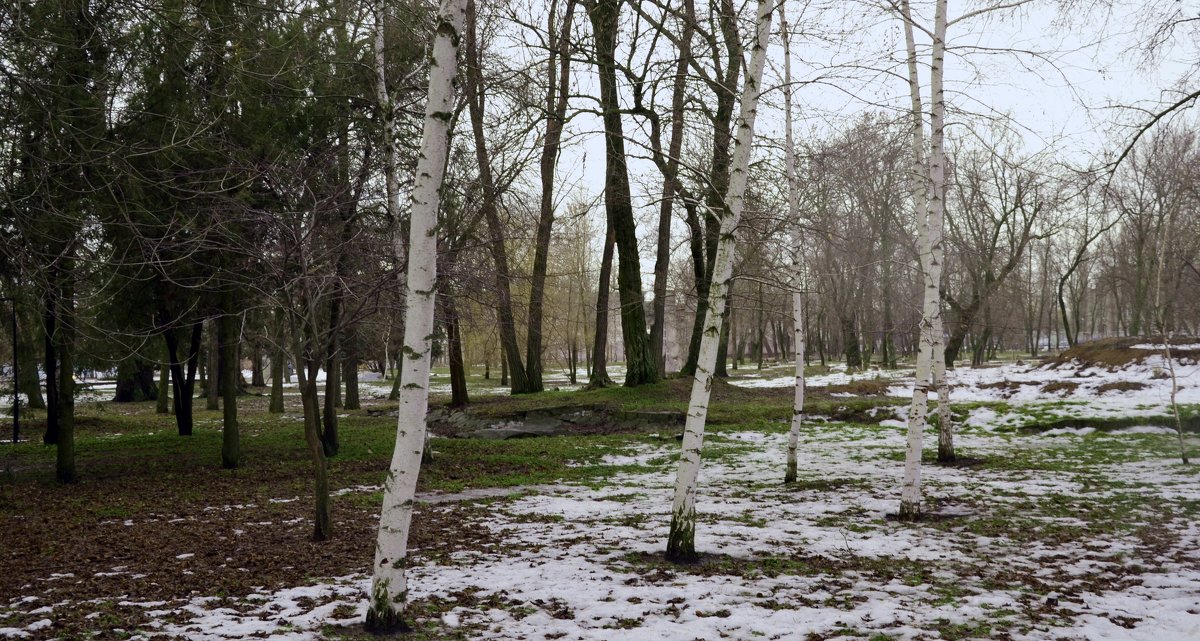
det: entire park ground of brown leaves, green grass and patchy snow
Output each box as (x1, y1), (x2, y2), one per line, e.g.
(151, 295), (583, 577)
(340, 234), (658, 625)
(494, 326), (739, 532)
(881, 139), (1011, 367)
(0, 345), (1200, 641)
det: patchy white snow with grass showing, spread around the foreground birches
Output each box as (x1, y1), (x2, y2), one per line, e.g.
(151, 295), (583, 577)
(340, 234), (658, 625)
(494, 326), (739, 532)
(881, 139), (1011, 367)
(63, 413), (1200, 641)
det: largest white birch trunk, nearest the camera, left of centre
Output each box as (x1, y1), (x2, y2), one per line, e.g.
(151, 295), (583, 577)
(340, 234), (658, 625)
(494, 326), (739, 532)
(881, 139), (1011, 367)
(366, 0), (467, 631)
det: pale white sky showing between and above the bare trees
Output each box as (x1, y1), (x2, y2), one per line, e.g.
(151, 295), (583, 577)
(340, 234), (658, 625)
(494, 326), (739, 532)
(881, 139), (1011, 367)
(501, 0), (1200, 287)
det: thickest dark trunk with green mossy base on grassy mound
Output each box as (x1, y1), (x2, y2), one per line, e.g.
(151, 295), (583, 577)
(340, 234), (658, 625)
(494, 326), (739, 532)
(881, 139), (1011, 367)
(588, 0), (659, 387)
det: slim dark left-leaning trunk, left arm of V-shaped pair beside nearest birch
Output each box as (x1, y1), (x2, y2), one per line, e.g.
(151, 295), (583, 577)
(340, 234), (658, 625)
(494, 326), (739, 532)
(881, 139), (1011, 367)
(463, 7), (530, 394)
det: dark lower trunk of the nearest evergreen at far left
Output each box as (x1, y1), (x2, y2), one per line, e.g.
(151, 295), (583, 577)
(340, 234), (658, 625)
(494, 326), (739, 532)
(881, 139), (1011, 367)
(54, 264), (79, 483)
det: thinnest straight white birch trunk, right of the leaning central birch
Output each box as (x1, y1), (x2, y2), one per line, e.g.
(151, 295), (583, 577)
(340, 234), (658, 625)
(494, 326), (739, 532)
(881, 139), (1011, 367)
(779, 5), (804, 483)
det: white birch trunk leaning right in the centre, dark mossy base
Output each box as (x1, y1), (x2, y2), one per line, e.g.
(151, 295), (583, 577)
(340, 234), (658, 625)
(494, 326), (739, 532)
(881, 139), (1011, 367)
(666, 0), (775, 561)
